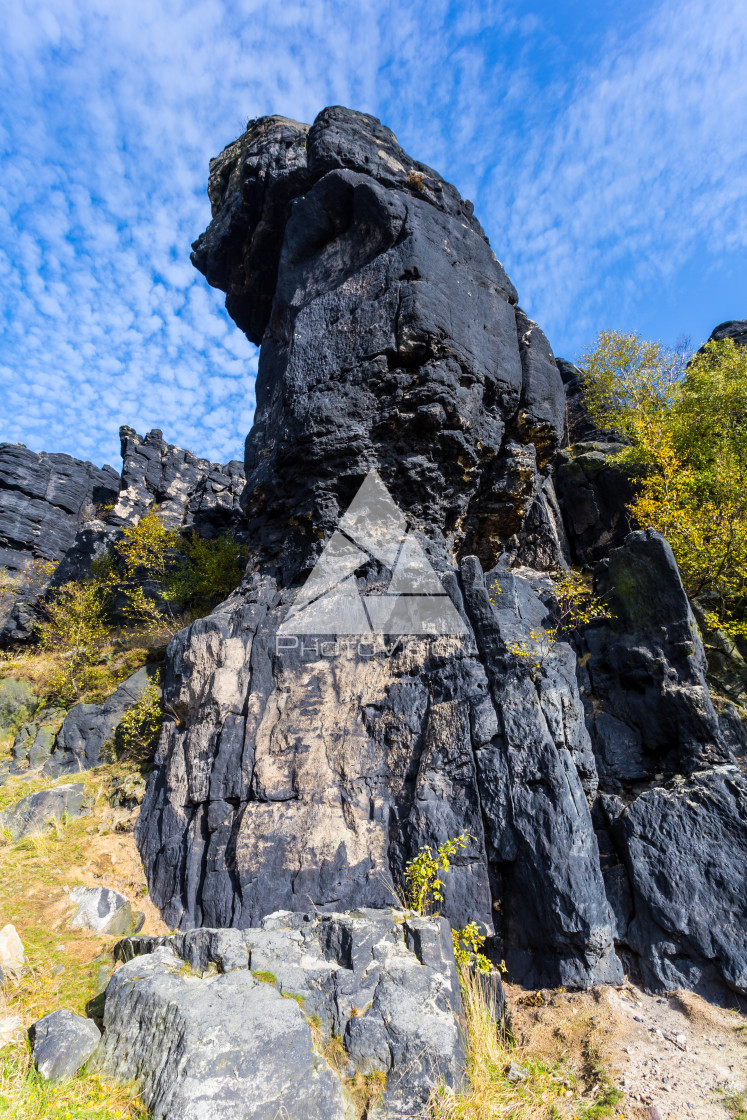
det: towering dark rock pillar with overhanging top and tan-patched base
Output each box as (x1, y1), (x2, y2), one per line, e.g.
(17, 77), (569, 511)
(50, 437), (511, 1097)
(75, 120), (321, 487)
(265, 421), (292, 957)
(138, 109), (622, 984)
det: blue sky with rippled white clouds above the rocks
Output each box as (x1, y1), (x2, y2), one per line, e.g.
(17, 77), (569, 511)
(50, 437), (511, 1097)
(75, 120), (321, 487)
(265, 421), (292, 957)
(0, 0), (747, 467)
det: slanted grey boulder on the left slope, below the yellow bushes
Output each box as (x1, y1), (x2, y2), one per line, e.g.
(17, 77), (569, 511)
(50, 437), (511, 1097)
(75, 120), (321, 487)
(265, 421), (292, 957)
(43, 665), (156, 777)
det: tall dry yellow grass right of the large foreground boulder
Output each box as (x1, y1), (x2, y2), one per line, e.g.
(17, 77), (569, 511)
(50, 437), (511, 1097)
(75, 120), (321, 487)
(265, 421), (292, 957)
(432, 973), (622, 1120)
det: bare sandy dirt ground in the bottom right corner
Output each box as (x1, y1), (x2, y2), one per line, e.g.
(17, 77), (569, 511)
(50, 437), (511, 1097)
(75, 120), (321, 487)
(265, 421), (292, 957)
(506, 984), (747, 1120)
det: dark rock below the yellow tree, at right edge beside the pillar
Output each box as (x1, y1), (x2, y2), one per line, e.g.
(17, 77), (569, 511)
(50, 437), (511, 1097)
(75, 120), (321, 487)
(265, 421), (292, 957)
(580, 531), (747, 995)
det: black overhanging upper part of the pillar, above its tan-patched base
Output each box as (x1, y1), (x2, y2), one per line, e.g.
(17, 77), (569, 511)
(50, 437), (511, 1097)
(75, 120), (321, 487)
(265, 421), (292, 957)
(193, 109), (563, 581)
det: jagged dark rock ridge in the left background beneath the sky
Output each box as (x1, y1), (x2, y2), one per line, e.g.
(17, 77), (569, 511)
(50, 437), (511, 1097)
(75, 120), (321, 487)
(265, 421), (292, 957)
(0, 427), (245, 643)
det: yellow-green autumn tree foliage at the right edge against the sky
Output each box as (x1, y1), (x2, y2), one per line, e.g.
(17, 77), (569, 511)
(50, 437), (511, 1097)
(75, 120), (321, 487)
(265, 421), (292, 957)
(585, 332), (747, 636)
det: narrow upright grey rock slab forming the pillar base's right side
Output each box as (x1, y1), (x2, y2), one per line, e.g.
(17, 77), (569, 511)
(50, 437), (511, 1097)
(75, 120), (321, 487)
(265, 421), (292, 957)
(463, 558), (623, 987)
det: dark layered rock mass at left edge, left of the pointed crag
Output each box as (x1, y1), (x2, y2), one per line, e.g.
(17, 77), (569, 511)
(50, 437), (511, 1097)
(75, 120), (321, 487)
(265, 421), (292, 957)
(0, 444), (119, 641)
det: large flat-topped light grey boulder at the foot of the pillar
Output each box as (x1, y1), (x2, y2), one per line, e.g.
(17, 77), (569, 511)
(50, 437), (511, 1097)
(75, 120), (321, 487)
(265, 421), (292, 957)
(96, 911), (464, 1120)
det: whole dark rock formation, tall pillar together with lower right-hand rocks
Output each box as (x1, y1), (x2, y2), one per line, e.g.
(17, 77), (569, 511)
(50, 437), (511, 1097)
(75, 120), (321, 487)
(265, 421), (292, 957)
(137, 108), (747, 1008)
